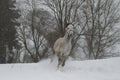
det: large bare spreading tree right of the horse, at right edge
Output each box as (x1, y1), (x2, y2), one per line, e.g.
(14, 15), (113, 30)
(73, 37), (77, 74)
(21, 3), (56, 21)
(83, 0), (120, 59)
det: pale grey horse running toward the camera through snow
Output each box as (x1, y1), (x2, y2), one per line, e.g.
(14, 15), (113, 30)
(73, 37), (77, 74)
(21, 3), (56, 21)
(53, 24), (74, 68)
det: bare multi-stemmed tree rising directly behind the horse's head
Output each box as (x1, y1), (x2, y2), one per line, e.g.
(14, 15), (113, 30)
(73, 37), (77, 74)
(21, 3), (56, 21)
(46, 0), (84, 36)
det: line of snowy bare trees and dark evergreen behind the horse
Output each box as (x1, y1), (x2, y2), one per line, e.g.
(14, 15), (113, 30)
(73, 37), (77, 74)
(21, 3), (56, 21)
(0, 0), (120, 63)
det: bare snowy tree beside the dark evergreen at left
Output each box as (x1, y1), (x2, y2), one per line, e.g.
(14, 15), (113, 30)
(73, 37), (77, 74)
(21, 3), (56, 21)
(18, 0), (50, 62)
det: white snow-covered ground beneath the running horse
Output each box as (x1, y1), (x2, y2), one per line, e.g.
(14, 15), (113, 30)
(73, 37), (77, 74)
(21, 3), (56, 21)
(0, 57), (120, 80)
